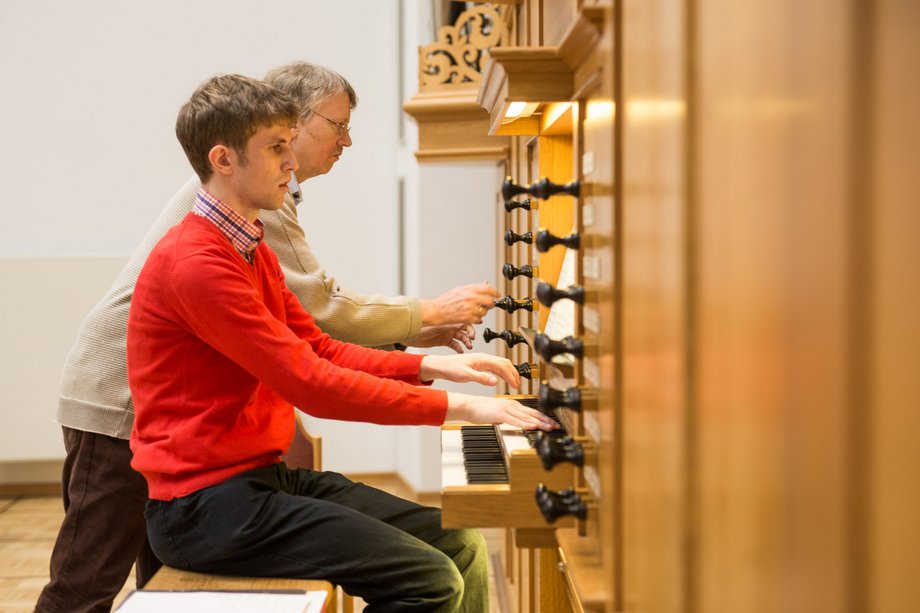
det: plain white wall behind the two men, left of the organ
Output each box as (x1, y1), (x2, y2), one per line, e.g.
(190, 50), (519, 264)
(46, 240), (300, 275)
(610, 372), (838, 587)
(0, 0), (398, 471)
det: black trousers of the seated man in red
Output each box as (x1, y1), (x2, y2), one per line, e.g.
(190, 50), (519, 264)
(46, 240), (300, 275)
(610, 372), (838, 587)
(146, 463), (489, 613)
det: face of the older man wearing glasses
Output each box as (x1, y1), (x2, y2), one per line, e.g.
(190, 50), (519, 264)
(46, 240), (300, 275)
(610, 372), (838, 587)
(293, 92), (351, 182)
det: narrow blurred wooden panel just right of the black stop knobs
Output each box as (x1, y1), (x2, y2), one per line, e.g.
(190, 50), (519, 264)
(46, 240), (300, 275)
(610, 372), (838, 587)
(617, 0), (688, 612)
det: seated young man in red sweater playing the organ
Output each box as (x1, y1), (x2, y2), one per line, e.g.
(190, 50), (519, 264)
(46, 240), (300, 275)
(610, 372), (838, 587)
(127, 75), (555, 611)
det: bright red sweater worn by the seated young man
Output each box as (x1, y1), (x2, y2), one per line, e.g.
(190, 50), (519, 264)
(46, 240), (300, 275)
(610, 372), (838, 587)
(128, 214), (447, 500)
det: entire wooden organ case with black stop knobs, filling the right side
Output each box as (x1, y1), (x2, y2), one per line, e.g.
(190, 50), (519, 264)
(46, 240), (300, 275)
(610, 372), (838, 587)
(406, 0), (920, 613)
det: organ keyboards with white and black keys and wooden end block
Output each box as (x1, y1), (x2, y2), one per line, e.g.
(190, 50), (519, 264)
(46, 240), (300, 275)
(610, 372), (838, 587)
(441, 396), (574, 528)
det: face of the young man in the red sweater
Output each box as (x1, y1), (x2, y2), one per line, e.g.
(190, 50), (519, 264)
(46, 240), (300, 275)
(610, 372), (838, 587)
(232, 124), (297, 219)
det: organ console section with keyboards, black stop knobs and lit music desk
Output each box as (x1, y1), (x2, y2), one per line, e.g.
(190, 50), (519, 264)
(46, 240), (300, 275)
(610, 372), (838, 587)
(419, 0), (616, 613)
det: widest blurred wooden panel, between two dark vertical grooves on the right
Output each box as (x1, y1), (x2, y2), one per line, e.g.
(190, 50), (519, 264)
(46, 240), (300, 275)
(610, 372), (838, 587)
(692, 0), (855, 613)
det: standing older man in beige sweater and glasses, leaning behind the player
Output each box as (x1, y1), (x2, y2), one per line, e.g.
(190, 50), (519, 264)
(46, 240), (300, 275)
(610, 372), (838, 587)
(36, 63), (498, 613)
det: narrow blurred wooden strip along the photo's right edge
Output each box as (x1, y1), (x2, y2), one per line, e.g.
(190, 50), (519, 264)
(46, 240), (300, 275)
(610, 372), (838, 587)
(858, 0), (920, 613)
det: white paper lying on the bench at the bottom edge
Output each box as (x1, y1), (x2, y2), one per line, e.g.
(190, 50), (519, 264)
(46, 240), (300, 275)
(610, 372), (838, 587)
(116, 590), (326, 613)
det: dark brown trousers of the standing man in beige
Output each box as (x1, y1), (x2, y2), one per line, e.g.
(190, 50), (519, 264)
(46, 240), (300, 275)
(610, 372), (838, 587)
(35, 427), (161, 613)
